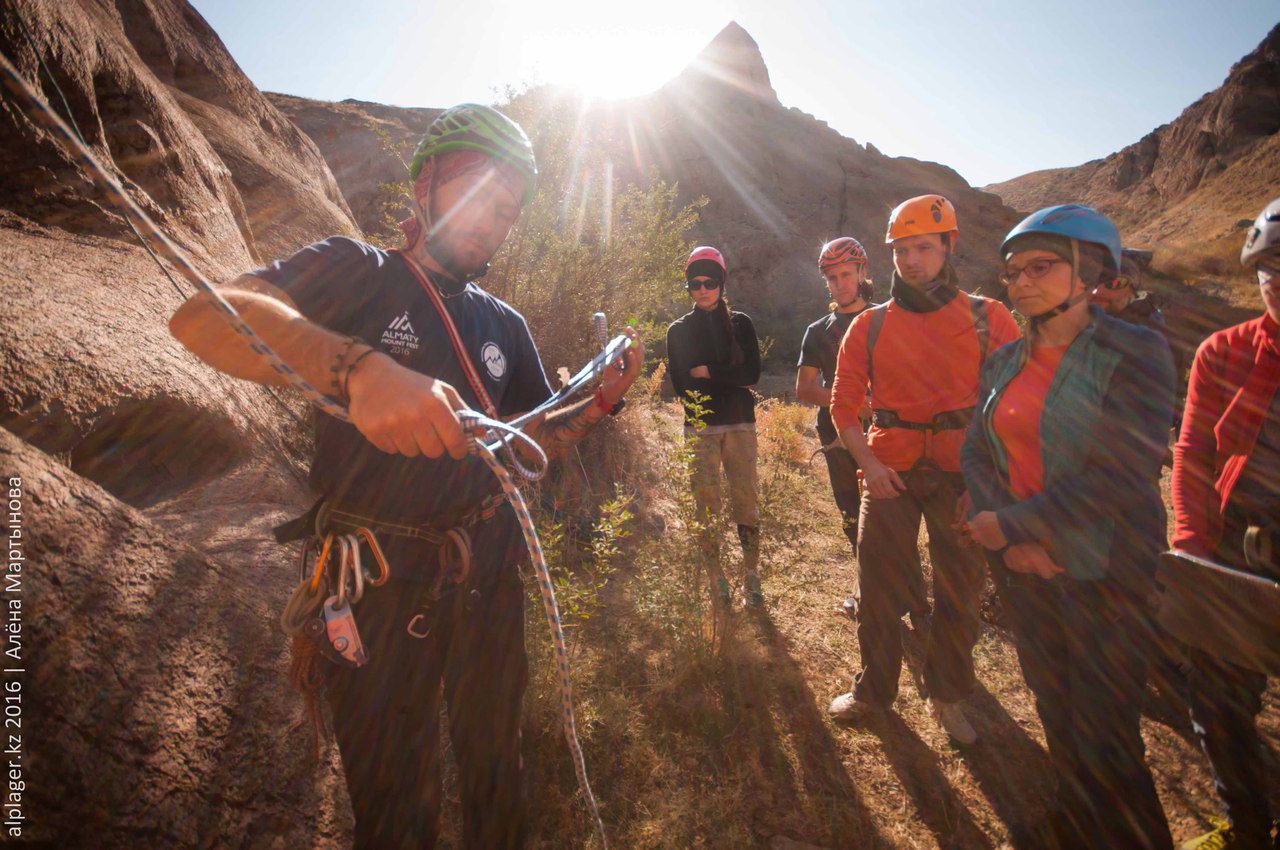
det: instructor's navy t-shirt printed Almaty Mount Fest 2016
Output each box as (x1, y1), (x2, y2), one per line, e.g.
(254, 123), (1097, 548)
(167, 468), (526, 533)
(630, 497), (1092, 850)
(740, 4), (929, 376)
(253, 237), (552, 527)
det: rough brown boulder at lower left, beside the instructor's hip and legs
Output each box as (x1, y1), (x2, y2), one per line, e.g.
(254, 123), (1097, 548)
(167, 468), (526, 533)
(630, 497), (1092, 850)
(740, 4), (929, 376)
(0, 429), (351, 849)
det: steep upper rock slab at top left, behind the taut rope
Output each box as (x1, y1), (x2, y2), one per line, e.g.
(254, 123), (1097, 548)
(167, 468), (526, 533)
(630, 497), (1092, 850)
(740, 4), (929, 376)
(0, 0), (356, 277)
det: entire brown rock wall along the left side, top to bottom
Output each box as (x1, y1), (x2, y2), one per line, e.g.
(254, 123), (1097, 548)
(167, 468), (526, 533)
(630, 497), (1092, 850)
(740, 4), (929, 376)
(0, 0), (358, 847)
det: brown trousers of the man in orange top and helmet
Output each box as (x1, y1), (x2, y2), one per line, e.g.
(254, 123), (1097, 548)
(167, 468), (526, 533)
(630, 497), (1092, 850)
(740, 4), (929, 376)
(852, 472), (986, 708)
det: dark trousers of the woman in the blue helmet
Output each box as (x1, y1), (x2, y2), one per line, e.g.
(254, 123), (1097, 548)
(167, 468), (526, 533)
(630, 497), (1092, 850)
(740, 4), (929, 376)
(992, 568), (1172, 850)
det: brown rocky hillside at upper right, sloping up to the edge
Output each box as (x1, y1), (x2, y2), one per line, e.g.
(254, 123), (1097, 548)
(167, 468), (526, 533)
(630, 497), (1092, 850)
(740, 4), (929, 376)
(987, 26), (1280, 274)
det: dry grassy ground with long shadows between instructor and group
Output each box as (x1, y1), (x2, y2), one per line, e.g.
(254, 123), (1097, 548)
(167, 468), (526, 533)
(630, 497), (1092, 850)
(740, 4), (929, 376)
(448, 376), (1276, 849)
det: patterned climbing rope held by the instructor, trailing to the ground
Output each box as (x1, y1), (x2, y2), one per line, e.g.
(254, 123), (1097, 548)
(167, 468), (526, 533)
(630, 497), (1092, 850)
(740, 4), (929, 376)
(0, 54), (611, 847)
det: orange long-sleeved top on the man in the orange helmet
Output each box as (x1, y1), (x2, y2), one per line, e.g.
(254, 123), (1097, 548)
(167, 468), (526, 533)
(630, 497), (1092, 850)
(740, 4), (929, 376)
(831, 292), (1020, 472)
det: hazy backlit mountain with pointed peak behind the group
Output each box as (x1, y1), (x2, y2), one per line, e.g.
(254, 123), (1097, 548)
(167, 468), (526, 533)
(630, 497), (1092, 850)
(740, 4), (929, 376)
(270, 23), (1018, 355)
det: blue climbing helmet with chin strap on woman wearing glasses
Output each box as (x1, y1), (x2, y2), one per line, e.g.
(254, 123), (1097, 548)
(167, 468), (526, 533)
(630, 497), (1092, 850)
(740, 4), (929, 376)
(1000, 204), (1121, 325)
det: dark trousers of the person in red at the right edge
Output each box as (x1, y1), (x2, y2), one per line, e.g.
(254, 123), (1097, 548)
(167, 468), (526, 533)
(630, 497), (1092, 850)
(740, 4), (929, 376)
(1187, 509), (1271, 847)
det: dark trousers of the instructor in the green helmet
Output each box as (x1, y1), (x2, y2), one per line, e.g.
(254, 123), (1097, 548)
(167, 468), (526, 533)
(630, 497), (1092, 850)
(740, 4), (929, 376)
(328, 566), (529, 850)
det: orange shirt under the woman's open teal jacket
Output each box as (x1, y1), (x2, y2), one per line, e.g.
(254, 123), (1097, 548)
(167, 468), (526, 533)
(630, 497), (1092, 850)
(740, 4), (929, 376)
(992, 344), (1070, 499)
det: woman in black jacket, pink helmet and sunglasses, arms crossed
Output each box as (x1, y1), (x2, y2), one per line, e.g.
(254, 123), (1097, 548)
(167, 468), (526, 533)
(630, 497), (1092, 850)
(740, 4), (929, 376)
(667, 246), (764, 607)
